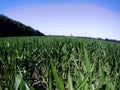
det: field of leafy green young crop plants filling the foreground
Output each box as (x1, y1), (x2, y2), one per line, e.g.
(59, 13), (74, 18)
(0, 37), (120, 90)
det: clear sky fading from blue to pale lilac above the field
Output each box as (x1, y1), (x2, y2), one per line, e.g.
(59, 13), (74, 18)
(0, 0), (120, 40)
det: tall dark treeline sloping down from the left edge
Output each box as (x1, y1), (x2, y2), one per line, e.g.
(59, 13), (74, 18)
(0, 15), (45, 37)
